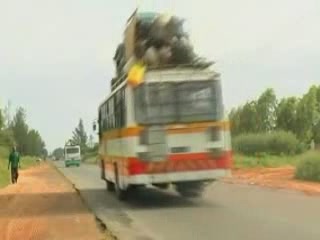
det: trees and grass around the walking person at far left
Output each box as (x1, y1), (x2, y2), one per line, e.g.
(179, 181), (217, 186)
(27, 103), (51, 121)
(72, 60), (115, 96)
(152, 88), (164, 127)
(0, 104), (47, 187)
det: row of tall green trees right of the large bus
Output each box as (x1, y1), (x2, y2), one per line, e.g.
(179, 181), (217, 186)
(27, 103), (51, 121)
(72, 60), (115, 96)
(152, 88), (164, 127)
(229, 85), (320, 144)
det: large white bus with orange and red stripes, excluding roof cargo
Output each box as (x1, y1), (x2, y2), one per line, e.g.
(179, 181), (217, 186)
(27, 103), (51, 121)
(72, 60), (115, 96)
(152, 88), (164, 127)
(98, 67), (232, 200)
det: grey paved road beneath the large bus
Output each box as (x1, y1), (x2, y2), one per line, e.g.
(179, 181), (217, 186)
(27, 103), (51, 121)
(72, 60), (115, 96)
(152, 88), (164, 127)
(57, 163), (320, 240)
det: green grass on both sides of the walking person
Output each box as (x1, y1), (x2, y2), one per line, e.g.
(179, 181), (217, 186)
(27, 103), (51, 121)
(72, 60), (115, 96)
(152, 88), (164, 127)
(0, 147), (37, 188)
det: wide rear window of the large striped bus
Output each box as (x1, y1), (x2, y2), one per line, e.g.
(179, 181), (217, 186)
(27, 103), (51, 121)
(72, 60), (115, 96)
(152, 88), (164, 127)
(134, 80), (223, 124)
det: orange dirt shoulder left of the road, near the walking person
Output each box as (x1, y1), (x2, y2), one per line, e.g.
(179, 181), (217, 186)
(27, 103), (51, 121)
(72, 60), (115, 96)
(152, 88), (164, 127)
(0, 164), (106, 240)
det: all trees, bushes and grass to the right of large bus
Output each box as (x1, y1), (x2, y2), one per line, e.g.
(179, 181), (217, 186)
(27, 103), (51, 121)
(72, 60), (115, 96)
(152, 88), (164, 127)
(229, 85), (320, 182)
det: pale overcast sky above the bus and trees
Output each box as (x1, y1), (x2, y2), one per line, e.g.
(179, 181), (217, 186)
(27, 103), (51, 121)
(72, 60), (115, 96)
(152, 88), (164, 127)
(0, 0), (320, 151)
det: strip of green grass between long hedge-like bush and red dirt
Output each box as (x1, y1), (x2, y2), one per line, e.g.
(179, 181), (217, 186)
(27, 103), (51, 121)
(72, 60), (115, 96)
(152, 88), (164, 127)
(234, 153), (308, 168)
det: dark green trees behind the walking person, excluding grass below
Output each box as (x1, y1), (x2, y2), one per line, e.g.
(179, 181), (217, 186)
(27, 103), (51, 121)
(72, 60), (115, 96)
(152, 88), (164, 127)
(0, 104), (48, 157)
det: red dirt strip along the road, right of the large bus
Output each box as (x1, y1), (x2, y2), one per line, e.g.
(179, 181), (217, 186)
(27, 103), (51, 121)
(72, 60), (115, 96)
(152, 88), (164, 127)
(225, 167), (320, 195)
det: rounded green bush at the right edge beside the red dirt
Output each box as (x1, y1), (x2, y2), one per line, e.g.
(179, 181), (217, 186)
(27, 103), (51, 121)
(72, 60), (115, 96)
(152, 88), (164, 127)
(295, 152), (320, 182)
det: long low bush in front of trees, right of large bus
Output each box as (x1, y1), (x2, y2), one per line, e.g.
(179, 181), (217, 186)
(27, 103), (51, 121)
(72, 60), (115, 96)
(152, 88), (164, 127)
(233, 131), (299, 156)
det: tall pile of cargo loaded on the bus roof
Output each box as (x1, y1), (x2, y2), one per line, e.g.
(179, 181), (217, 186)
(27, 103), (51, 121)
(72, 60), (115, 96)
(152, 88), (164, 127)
(114, 12), (212, 75)
